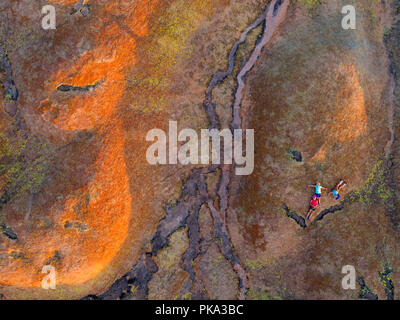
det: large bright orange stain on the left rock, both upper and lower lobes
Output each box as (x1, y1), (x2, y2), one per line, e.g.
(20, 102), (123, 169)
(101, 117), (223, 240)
(0, 1), (162, 288)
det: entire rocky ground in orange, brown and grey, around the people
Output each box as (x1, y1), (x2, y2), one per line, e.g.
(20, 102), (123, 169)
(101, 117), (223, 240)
(0, 0), (400, 299)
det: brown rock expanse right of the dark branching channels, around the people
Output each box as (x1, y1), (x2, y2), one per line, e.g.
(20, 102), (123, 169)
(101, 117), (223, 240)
(229, 1), (399, 299)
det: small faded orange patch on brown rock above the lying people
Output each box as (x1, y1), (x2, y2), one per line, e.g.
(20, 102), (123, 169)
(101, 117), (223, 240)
(312, 64), (368, 161)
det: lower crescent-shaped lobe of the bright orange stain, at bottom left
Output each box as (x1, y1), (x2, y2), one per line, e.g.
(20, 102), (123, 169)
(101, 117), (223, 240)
(0, 123), (131, 287)
